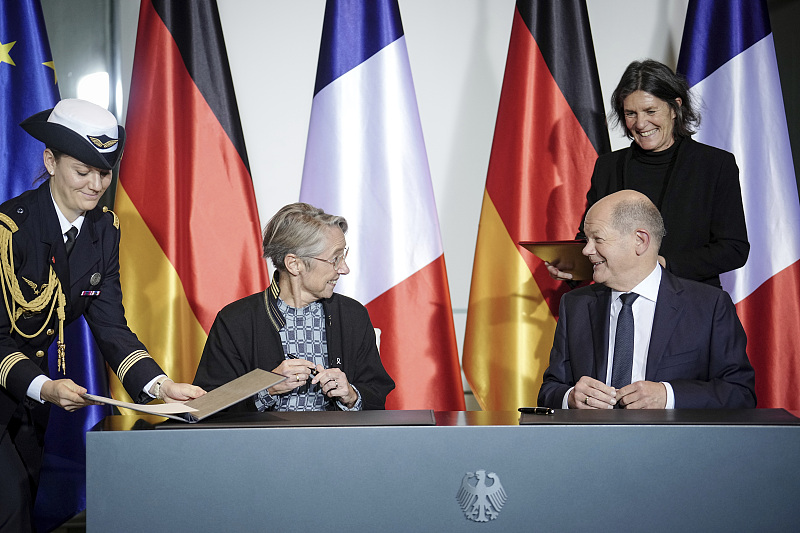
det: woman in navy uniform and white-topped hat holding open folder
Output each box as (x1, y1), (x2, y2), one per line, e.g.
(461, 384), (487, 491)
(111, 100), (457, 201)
(0, 100), (204, 531)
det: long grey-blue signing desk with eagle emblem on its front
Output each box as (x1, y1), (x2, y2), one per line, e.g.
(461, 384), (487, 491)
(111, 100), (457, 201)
(86, 409), (800, 533)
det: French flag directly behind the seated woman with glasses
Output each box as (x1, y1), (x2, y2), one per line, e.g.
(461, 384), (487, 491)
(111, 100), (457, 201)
(300, 0), (464, 411)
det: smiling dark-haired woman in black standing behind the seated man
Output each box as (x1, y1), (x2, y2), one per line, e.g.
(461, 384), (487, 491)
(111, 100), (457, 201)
(548, 59), (750, 287)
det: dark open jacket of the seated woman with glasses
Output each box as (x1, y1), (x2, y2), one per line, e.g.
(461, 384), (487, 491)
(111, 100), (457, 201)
(194, 288), (394, 411)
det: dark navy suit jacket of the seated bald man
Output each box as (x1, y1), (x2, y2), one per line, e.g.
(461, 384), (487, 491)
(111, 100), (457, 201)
(539, 271), (756, 409)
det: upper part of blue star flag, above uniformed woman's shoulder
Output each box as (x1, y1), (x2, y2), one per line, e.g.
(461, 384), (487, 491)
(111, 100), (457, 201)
(0, 0), (59, 203)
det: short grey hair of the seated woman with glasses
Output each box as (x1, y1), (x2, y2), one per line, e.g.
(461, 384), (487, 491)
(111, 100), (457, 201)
(263, 202), (347, 272)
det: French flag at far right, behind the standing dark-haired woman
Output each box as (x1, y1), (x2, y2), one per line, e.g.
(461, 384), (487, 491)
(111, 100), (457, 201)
(678, 0), (800, 410)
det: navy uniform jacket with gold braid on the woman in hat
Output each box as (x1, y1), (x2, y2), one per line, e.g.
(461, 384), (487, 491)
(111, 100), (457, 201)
(0, 181), (163, 434)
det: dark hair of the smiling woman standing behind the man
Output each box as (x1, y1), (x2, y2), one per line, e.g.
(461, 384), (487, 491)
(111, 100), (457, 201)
(609, 59), (700, 139)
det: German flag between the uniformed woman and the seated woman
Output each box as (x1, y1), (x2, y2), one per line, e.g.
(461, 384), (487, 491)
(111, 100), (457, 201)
(114, 0), (268, 397)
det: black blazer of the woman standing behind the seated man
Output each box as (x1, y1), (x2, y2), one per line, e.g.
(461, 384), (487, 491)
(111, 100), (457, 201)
(581, 138), (750, 287)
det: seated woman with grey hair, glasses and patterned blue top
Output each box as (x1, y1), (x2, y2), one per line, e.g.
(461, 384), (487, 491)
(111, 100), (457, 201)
(194, 203), (394, 411)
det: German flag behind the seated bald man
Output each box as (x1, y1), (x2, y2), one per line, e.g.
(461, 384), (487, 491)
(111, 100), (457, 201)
(463, 0), (610, 411)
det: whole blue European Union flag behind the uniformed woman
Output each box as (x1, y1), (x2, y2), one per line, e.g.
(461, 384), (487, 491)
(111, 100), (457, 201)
(0, 0), (110, 531)
